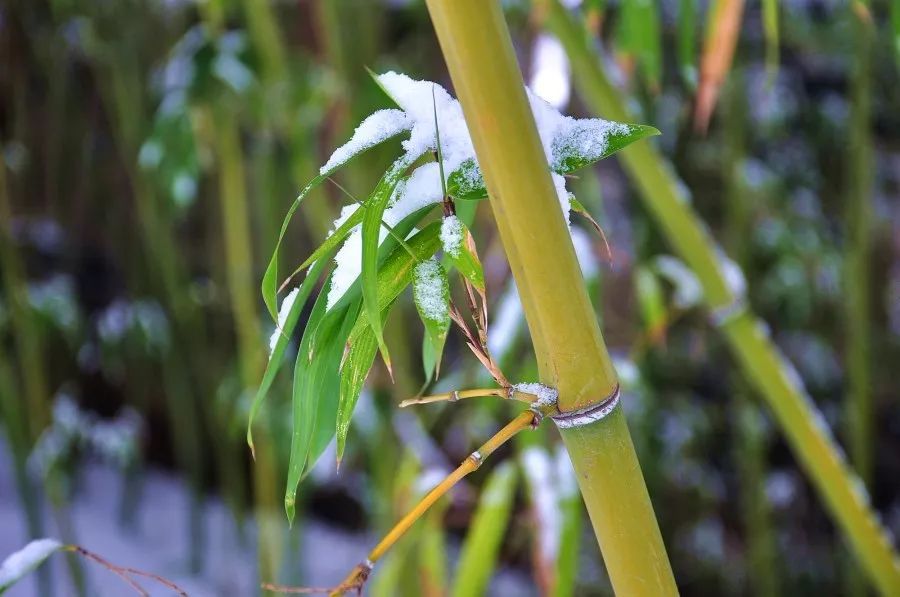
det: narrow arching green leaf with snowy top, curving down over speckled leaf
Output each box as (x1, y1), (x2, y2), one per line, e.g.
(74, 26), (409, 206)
(362, 154), (418, 375)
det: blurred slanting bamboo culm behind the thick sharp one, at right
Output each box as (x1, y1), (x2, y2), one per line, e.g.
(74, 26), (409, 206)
(537, 0), (900, 595)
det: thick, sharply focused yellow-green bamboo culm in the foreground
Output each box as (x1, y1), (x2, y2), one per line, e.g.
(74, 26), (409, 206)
(427, 0), (678, 596)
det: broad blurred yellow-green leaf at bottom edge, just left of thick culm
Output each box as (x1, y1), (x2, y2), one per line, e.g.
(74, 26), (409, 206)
(453, 461), (517, 597)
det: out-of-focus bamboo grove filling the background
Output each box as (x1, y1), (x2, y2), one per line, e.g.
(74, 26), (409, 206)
(0, 0), (900, 597)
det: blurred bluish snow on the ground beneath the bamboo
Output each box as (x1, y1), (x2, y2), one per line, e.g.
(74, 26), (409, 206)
(0, 435), (536, 597)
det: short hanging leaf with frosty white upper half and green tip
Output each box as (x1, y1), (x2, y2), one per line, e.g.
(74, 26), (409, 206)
(413, 259), (450, 378)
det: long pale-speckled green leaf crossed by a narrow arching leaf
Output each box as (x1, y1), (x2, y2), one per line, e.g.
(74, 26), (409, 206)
(334, 222), (440, 461)
